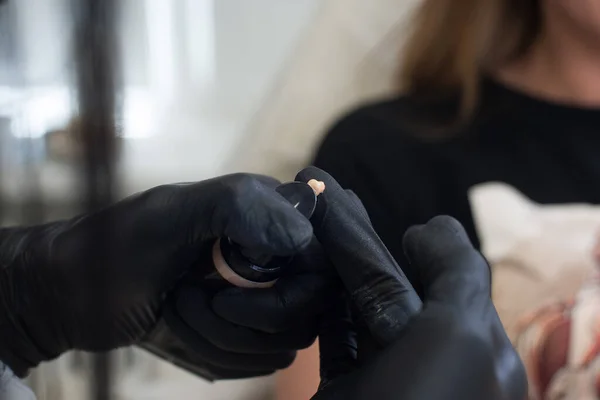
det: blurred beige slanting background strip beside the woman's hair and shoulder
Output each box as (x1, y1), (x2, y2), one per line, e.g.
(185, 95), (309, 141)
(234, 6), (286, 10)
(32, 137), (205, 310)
(227, 0), (417, 179)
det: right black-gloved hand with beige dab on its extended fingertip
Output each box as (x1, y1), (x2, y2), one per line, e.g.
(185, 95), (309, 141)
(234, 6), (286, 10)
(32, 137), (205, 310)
(298, 168), (527, 400)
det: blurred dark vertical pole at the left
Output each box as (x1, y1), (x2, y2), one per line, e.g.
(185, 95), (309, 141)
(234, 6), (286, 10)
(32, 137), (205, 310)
(73, 0), (118, 400)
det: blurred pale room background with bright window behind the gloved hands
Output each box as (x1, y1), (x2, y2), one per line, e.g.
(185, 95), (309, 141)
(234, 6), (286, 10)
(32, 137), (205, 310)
(0, 0), (415, 400)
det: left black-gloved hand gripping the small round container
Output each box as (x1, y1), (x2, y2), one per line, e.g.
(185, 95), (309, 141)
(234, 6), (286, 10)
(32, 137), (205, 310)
(0, 174), (326, 378)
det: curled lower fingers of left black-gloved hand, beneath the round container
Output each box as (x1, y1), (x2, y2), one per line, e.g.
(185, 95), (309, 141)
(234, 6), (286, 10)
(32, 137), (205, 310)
(155, 234), (332, 379)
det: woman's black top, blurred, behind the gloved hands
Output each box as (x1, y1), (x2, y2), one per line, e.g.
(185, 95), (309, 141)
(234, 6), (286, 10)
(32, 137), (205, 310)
(314, 81), (600, 290)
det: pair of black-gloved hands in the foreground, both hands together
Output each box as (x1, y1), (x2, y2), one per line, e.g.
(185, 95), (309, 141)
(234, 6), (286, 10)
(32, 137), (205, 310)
(0, 168), (526, 400)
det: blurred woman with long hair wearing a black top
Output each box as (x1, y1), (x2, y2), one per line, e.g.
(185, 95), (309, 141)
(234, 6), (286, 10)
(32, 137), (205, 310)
(300, 0), (600, 400)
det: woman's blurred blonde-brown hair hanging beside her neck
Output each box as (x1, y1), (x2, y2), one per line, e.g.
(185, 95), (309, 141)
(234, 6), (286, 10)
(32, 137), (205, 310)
(399, 0), (542, 121)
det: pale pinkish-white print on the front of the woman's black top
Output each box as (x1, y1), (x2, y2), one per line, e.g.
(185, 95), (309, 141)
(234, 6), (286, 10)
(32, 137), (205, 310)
(470, 183), (600, 400)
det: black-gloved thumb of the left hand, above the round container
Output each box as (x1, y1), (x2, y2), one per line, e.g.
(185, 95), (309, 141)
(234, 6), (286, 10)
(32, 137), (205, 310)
(181, 174), (312, 256)
